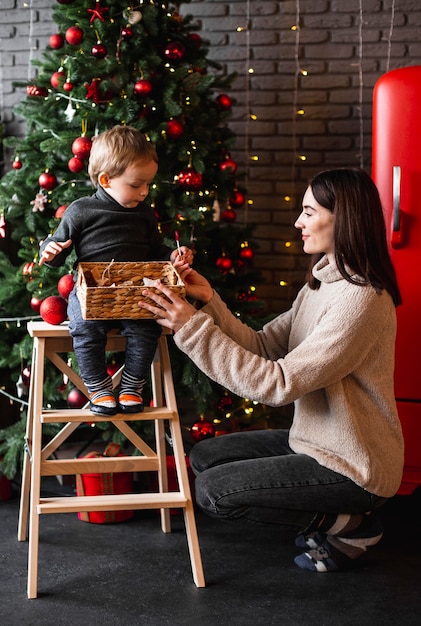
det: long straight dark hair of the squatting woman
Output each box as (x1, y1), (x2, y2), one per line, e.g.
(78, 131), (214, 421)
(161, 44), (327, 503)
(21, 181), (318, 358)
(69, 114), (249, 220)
(308, 168), (402, 306)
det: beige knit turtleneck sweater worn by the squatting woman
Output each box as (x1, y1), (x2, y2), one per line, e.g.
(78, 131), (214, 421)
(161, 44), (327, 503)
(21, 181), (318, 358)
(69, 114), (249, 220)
(175, 257), (403, 497)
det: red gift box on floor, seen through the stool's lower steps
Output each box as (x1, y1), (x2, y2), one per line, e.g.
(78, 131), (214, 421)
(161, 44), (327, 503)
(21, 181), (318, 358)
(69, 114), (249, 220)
(76, 444), (134, 524)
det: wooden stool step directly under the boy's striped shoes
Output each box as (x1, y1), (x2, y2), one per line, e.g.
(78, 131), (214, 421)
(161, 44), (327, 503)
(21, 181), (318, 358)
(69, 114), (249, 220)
(41, 406), (177, 424)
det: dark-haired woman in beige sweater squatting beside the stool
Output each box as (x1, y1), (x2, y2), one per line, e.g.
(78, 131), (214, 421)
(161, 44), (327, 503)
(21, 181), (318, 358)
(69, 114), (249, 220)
(141, 169), (403, 572)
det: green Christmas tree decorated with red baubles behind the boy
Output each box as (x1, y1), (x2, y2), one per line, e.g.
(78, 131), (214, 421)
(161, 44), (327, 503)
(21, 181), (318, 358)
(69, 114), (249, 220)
(0, 0), (288, 472)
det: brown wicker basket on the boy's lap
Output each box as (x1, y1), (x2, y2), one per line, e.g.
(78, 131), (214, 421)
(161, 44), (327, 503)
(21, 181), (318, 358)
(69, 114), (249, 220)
(76, 261), (186, 320)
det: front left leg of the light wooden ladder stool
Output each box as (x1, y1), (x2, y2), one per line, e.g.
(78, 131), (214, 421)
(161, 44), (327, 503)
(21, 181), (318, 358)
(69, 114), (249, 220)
(28, 338), (45, 598)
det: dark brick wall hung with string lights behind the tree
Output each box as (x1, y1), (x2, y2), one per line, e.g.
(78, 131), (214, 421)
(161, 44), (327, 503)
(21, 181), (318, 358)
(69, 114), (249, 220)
(0, 0), (421, 311)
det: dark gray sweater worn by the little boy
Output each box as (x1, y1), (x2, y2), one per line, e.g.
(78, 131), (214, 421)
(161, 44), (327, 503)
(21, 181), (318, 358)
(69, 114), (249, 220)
(40, 187), (171, 267)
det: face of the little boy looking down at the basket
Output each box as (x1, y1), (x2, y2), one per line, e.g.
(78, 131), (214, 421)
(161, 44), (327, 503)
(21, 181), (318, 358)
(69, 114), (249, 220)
(98, 161), (158, 209)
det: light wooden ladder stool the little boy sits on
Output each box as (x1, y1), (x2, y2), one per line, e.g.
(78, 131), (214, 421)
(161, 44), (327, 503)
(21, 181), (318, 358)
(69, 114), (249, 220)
(18, 322), (205, 598)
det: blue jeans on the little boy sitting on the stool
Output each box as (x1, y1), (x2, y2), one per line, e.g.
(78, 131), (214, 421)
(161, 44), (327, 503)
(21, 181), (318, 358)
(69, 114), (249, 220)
(68, 289), (162, 389)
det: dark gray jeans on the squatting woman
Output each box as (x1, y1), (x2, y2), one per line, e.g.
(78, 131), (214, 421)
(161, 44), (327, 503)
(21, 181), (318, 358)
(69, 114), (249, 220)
(190, 430), (385, 532)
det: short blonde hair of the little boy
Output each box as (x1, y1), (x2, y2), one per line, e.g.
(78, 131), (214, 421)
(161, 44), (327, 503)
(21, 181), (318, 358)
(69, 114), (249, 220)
(88, 126), (158, 187)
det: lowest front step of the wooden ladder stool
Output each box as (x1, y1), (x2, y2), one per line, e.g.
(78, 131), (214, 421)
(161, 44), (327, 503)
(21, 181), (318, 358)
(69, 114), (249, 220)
(37, 491), (188, 515)
